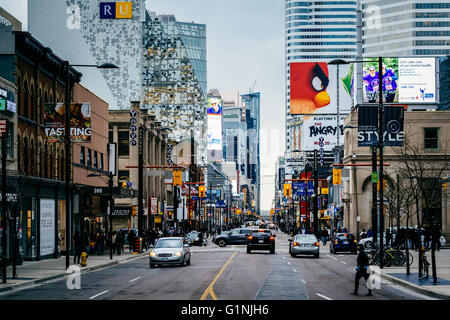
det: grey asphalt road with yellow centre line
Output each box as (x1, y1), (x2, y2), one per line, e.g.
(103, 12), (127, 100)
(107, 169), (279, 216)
(0, 232), (436, 300)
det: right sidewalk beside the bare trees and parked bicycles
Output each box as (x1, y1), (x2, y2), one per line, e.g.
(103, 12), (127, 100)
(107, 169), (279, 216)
(381, 248), (450, 300)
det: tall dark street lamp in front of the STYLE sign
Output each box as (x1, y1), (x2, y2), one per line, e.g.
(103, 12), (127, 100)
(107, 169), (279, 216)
(328, 57), (384, 269)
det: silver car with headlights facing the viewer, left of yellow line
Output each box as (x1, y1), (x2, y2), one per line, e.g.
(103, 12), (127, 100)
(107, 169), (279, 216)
(149, 237), (191, 268)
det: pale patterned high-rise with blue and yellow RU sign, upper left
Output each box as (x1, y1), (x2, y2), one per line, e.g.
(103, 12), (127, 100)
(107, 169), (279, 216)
(28, 0), (146, 109)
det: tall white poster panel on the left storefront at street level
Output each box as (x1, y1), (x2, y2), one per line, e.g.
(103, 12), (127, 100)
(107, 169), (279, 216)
(40, 199), (55, 256)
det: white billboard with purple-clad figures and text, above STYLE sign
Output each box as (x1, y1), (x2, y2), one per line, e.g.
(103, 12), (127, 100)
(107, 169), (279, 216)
(362, 57), (438, 103)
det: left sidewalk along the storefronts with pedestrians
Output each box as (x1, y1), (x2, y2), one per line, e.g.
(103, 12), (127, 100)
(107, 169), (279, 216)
(0, 250), (147, 299)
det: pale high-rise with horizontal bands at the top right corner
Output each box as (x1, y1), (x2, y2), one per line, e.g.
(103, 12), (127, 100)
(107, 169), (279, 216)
(360, 0), (450, 57)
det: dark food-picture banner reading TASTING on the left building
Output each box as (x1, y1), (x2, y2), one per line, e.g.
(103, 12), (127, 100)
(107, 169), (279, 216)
(44, 102), (91, 142)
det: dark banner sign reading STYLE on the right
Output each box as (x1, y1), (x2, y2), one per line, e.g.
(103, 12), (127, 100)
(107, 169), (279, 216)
(358, 106), (404, 147)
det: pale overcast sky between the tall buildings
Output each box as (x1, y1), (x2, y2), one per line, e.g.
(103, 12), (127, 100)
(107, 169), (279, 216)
(0, 0), (285, 210)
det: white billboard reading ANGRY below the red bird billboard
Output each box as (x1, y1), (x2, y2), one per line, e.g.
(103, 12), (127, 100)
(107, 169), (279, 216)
(301, 115), (346, 151)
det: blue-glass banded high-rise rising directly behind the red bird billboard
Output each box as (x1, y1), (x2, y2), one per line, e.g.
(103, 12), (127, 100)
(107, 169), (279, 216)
(285, 0), (357, 157)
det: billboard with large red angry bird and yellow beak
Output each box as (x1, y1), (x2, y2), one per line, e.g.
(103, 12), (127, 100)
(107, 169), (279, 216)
(290, 62), (352, 115)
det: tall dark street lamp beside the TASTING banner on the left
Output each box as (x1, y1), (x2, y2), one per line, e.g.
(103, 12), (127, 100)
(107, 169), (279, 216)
(64, 61), (118, 269)
